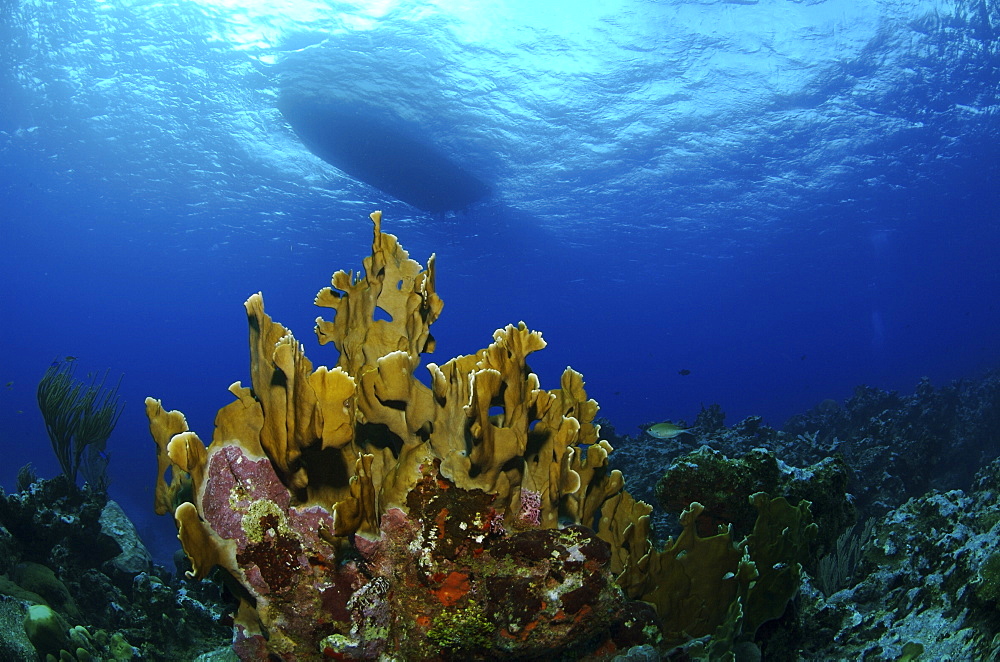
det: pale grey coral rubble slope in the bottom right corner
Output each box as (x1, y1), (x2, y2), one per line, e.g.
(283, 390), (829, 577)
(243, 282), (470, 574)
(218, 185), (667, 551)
(800, 461), (1000, 660)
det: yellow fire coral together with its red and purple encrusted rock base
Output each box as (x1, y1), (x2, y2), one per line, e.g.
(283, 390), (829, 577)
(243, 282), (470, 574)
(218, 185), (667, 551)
(146, 212), (808, 659)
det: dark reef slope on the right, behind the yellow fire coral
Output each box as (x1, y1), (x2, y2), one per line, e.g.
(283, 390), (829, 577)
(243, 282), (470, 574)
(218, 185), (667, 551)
(602, 373), (1000, 660)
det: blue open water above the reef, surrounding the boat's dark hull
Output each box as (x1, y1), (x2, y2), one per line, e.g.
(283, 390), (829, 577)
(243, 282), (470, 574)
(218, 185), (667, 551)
(0, 0), (1000, 564)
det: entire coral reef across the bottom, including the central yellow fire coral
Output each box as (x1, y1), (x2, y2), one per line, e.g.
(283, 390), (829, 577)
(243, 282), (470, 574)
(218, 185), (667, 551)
(7, 209), (1000, 662)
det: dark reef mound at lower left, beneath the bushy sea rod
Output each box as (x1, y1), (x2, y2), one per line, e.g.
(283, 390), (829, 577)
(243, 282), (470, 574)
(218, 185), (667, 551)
(0, 475), (228, 661)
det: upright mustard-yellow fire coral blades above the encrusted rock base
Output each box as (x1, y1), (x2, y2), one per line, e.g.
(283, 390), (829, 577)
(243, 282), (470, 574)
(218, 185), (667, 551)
(147, 212), (623, 535)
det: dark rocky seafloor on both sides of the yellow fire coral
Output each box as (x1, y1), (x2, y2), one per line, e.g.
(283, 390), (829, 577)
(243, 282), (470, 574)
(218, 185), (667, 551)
(0, 374), (1000, 661)
